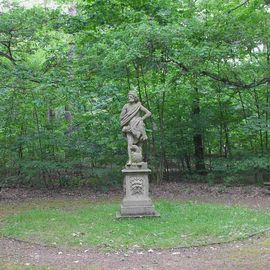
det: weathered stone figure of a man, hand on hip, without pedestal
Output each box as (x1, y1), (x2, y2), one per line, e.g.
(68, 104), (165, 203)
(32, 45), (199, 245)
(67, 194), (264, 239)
(120, 91), (151, 165)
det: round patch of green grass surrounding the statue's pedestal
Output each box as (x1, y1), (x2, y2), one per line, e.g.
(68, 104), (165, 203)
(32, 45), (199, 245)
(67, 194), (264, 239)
(0, 200), (270, 250)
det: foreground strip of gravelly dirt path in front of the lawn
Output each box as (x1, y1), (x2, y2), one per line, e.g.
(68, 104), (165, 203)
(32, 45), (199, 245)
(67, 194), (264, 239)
(0, 233), (270, 270)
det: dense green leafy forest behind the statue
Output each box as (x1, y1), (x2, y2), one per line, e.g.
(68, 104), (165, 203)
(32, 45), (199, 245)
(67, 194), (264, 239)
(0, 0), (270, 190)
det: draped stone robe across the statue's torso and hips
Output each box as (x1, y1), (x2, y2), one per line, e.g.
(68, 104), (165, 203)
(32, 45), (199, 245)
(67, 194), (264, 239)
(120, 102), (147, 144)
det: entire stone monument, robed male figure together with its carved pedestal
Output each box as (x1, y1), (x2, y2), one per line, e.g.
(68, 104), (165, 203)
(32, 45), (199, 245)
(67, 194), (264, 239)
(116, 91), (159, 218)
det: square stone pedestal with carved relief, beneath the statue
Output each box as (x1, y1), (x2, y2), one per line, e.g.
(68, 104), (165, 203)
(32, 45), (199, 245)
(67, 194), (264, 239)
(116, 163), (159, 218)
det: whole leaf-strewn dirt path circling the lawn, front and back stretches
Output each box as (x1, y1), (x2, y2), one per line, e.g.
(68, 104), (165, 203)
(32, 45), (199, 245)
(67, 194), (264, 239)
(0, 184), (270, 270)
